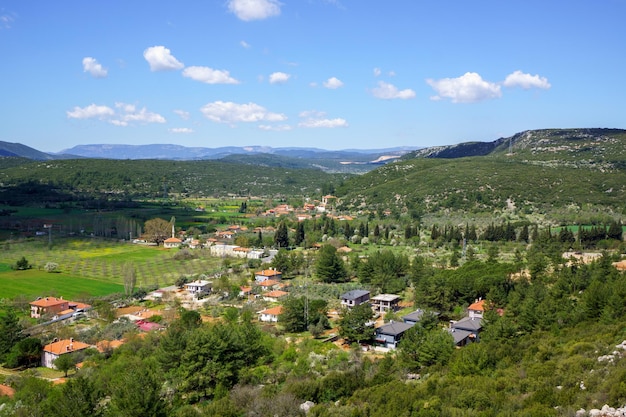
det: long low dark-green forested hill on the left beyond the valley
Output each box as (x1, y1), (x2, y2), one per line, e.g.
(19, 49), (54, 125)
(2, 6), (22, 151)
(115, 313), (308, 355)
(0, 158), (347, 202)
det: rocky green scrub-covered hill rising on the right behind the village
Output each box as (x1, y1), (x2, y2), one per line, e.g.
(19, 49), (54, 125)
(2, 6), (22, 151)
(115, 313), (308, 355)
(339, 129), (626, 213)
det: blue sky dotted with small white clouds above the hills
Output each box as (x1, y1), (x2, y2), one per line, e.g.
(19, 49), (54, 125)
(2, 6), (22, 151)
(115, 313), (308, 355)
(0, 0), (626, 152)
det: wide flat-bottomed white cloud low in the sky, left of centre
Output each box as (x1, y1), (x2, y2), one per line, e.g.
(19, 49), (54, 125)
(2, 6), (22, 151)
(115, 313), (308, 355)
(200, 101), (287, 125)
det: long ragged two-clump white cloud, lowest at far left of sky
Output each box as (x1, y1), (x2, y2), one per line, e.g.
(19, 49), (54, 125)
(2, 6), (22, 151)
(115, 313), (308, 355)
(66, 103), (165, 126)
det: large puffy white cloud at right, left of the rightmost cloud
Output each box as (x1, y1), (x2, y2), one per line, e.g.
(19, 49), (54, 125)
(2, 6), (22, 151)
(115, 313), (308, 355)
(426, 72), (502, 103)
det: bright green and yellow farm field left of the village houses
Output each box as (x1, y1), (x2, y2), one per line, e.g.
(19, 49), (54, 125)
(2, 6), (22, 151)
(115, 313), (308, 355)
(0, 238), (228, 298)
